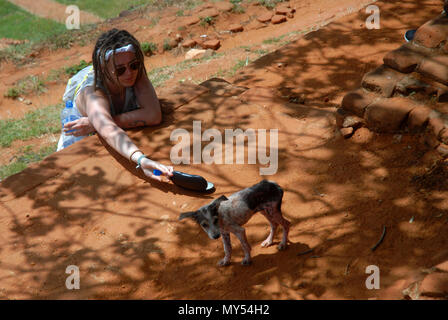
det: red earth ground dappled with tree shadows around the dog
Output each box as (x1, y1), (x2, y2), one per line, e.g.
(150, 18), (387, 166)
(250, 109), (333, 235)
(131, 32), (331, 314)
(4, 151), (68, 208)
(0, 0), (448, 299)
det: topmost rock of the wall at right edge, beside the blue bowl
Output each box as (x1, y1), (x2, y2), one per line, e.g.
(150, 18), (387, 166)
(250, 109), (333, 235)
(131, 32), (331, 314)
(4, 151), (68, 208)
(413, 16), (448, 48)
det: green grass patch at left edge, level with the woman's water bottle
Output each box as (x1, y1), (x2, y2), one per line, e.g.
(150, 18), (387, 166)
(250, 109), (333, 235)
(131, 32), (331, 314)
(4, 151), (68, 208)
(0, 103), (63, 147)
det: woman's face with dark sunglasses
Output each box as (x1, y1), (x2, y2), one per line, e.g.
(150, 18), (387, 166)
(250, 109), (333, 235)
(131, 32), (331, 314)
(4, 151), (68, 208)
(107, 52), (140, 87)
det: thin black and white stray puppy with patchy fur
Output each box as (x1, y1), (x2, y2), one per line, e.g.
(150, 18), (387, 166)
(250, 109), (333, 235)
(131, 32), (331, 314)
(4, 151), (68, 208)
(179, 180), (291, 266)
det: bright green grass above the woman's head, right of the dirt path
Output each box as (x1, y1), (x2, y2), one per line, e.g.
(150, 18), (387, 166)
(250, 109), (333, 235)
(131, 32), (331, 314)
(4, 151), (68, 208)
(56, 0), (148, 19)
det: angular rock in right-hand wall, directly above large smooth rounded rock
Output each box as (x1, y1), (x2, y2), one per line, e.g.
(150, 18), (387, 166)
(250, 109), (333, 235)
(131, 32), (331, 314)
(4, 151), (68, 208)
(362, 65), (404, 98)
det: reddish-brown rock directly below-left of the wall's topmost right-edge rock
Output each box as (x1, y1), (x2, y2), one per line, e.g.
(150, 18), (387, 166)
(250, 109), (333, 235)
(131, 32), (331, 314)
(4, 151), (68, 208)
(383, 43), (430, 73)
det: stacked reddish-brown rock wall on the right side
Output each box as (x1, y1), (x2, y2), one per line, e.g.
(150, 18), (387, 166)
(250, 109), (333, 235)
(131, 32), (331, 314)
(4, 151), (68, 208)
(336, 14), (448, 158)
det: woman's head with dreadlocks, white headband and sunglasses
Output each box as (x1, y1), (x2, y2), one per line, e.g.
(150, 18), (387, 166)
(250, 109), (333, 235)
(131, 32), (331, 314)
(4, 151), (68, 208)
(92, 29), (146, 89)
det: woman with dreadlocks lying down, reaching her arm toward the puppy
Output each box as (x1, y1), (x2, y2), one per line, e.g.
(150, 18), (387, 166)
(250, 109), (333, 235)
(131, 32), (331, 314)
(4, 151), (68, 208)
(58, 29), (173, 181)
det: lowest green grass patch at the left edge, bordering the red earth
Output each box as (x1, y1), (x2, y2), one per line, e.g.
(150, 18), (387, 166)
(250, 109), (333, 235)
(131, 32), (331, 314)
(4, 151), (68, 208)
(0, 143), (57, 180)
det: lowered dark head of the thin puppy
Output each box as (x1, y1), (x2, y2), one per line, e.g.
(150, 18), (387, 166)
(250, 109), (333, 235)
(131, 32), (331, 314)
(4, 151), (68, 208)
(179, 196), (228, 239)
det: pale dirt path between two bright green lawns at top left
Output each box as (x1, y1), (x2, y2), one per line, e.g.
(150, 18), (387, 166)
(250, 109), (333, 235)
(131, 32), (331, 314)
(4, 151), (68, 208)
(8, 0), (102, 25)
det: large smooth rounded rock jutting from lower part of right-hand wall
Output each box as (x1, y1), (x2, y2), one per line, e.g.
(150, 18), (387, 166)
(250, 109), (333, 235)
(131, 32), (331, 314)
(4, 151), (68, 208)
(364, 97), (417, 133)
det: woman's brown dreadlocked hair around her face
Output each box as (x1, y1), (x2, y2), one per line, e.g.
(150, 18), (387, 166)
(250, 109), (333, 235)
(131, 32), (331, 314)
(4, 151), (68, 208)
(92, 28), (146, 90)
